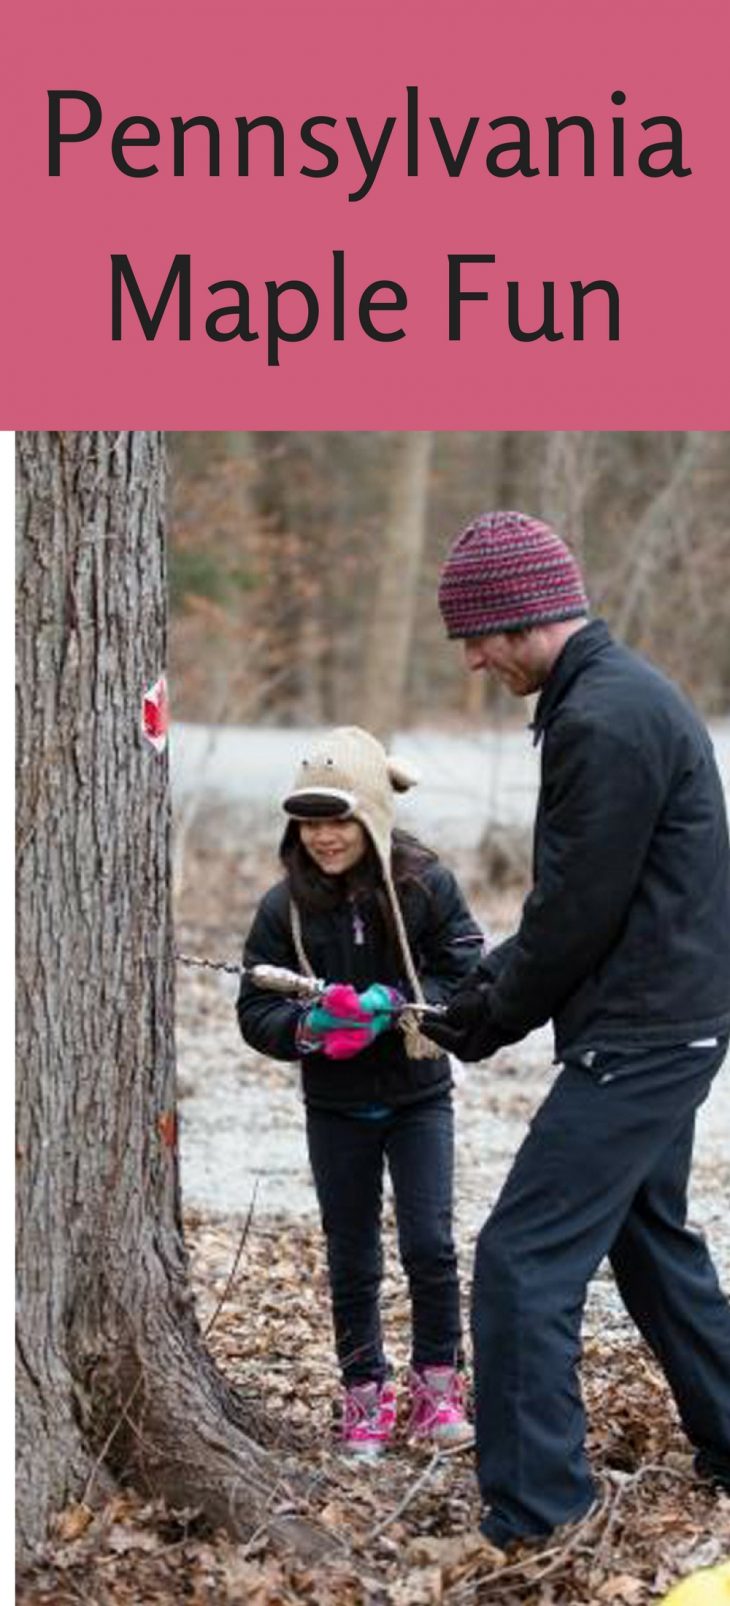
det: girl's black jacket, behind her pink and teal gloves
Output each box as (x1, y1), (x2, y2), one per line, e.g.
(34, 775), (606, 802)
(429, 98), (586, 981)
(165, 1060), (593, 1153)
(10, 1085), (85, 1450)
(237, 861), (481, 1110)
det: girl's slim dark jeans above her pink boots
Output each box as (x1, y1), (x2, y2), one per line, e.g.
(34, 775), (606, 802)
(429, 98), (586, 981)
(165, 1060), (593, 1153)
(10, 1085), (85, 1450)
(306, 1098), (460, 1386)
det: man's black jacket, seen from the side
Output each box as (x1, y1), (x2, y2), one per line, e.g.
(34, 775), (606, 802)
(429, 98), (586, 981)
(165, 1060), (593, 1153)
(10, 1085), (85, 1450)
(485, 620), (730, 1057)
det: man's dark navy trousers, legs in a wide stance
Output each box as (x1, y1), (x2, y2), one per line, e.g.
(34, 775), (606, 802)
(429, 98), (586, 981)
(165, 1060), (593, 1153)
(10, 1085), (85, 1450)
(472, 1042), (730, 1545)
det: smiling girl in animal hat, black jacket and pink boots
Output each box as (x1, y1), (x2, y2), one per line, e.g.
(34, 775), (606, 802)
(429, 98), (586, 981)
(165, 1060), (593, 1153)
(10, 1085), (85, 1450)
(237, 726), (481, 1455)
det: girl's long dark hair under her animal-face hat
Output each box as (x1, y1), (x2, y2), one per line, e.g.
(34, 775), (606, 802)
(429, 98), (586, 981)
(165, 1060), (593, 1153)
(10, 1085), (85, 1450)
(279, 819), (438, 957)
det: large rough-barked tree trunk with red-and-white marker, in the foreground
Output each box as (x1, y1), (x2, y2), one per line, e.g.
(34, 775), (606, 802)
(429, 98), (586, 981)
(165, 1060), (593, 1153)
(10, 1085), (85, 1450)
(18, 432), (325, 1558)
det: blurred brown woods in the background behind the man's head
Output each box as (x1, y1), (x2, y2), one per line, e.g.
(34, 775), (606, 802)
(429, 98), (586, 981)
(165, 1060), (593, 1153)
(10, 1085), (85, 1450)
(170, 432), (730, 734)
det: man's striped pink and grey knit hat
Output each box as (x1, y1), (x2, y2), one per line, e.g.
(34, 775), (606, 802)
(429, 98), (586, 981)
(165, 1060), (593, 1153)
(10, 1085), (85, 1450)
(438, 512), (589, 636)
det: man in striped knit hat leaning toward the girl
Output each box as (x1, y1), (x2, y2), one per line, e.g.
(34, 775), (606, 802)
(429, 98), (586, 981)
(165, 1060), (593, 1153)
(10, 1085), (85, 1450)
(428, 512), (730, 1550)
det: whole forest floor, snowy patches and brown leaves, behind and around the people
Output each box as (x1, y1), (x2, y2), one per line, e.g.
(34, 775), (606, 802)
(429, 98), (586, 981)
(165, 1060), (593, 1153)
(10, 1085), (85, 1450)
(19, 808), (730, 1606)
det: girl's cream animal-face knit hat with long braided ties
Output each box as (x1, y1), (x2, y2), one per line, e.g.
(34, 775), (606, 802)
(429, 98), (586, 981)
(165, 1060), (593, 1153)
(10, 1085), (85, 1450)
(282, 724), (441, 1057)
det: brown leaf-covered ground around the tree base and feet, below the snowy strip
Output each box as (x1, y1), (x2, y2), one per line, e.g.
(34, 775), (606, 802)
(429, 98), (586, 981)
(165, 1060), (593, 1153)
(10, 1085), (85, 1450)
(19, 1214), (730, 1606)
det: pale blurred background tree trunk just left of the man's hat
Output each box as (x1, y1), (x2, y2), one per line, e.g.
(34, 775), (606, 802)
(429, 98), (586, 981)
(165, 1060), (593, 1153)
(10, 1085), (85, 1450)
(363, 430), (433, 742)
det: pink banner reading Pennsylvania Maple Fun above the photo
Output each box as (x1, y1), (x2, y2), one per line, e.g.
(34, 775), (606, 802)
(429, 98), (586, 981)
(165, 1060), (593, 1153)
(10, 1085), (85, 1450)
(0, 0), (730, 429)
